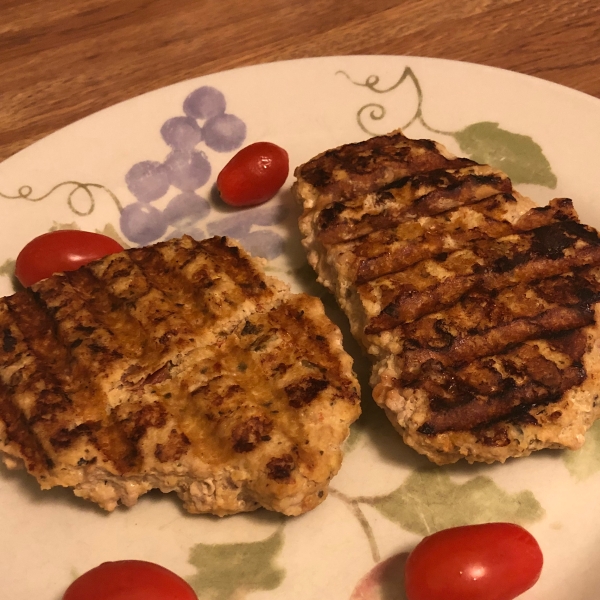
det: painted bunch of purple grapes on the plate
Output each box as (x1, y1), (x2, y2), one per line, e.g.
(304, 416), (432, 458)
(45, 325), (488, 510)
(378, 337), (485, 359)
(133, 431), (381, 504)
(121, 86), (258, 248)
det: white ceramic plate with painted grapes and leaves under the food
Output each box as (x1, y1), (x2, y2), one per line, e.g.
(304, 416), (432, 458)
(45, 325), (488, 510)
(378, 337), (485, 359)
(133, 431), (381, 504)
(0, 56), (600, 600)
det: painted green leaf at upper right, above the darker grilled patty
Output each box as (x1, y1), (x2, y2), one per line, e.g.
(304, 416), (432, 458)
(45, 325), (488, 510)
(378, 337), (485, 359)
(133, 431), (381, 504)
(452, 121), (556, 189)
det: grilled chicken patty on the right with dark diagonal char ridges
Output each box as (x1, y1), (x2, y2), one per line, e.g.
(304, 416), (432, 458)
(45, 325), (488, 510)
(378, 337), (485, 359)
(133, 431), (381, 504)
(294, 131), (600, 464)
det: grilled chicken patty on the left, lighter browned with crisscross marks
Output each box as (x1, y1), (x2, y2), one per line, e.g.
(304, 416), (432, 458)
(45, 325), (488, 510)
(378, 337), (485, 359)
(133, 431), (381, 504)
(0, 236), (360, 515)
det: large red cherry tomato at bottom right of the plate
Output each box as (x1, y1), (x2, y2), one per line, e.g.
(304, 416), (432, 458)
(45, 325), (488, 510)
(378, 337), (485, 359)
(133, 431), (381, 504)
(405, 523), (543, 600)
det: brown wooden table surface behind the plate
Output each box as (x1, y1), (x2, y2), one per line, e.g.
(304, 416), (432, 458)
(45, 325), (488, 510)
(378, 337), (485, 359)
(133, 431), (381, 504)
(0, 0), (600, 160)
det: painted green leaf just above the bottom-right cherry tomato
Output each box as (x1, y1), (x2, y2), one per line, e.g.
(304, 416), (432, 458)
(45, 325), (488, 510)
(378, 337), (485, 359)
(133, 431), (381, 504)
(370, 469), (544, 535)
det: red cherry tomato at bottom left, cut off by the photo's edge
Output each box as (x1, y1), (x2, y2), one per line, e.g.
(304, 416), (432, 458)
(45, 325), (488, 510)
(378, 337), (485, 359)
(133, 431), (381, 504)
(63, 560), (198, 600)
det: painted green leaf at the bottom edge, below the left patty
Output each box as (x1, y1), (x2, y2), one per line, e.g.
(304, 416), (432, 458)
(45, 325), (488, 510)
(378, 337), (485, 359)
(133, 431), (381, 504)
(188, 529), (285, 600)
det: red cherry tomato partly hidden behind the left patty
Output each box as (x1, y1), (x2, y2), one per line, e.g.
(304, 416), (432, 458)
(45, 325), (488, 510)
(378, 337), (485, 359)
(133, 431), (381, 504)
(15, 229), (123, 287)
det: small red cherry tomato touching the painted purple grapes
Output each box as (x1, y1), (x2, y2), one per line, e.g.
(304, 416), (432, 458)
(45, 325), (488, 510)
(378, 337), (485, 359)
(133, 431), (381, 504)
(217, 142), (290, 206)
